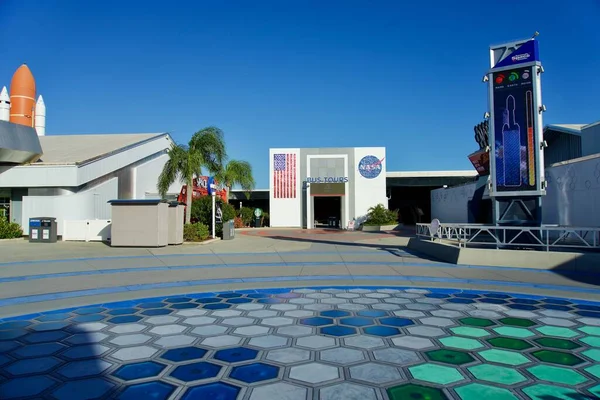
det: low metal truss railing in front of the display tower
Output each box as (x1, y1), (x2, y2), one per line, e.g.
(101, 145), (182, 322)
(417, 223), (600, 251)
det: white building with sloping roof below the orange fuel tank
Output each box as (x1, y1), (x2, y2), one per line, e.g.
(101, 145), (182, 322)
(0, 133), (181, 235)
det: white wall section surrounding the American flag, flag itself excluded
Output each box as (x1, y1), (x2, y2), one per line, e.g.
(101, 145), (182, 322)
(269, 149), (302, 228)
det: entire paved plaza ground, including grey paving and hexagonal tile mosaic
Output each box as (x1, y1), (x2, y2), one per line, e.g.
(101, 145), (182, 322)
(0, 230), (600, 400)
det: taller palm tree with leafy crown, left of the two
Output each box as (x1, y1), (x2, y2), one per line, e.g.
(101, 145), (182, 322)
(157, 126), (227, 224)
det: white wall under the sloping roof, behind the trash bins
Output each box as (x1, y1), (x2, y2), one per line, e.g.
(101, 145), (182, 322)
(21, 178), (118, 235)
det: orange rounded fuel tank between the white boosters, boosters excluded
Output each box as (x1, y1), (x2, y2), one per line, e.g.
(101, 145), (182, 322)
(10, 64), (35, 127)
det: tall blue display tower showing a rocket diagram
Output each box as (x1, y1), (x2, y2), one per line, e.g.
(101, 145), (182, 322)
(484, 33), (546, 226)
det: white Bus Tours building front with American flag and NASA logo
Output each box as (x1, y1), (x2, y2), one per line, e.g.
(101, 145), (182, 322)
(269, 147), (387, 229)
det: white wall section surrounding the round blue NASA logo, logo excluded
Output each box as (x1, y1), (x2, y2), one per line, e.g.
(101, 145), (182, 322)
(349, 147), (388, 220)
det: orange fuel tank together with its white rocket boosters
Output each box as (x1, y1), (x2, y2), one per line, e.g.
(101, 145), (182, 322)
(0, 64), (46, 136)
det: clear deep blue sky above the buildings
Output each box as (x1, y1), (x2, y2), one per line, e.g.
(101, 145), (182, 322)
(0, 0), (600, 188)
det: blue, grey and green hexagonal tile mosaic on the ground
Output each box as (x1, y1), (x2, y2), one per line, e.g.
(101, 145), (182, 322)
(0, 287), (600, 400)
